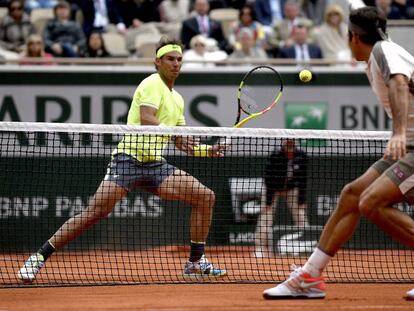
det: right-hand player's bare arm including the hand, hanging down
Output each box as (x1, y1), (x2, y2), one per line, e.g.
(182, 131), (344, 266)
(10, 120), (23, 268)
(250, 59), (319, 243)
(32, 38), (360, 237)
(384, 74), (409, 160)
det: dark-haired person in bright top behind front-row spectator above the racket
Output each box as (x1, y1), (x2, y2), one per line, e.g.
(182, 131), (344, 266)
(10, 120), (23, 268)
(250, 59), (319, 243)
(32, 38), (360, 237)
(229, 4), (266, 49)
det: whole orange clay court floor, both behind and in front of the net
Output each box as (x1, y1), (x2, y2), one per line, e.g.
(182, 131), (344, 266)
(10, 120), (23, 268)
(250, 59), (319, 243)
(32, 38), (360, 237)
(0, 247), (414, 311)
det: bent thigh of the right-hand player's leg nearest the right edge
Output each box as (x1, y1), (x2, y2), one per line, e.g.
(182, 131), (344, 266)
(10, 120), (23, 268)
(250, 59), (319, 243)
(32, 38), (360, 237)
(360, 152), (414, 208)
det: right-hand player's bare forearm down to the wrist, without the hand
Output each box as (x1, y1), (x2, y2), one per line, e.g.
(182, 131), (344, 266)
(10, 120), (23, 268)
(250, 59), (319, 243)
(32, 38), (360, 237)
(390, 77), (409, 135)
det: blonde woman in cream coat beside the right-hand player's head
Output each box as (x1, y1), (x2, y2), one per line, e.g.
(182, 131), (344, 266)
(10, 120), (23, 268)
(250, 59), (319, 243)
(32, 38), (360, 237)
(314, 4), (351, 60)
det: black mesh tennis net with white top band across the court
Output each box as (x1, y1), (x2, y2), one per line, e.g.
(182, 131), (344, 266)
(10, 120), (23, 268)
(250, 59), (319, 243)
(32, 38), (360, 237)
(0, 122), (414, 287)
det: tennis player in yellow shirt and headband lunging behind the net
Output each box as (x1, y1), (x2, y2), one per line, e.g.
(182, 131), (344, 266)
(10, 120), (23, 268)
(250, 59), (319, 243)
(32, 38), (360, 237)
(17, 37), (226, 282)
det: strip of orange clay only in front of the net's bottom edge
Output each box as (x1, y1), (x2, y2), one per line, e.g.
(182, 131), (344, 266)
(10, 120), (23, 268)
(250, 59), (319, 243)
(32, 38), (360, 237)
(0, 284), (414, 311)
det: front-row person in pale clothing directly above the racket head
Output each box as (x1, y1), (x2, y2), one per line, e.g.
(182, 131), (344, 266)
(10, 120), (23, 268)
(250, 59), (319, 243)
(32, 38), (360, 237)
(229, 27), (267, 61)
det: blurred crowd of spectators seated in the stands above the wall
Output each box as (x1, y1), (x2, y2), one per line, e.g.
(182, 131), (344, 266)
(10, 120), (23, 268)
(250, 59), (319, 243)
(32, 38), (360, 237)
(0, 0), (414, 66)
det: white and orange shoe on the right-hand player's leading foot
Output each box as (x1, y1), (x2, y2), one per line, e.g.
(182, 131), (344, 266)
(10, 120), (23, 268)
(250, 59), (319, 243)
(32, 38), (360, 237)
(263, 266), (326, 299)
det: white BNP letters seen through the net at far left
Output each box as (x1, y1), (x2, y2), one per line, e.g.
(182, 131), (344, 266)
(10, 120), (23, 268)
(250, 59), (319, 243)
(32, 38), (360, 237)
(0, 197), (49, 219)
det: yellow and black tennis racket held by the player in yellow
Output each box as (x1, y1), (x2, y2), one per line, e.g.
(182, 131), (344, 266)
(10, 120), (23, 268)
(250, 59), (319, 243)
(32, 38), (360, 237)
(220, 65), (283, 145)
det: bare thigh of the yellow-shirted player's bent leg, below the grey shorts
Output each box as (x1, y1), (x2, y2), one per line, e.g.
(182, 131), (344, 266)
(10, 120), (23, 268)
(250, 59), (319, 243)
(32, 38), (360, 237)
(157, 169), (214, 204)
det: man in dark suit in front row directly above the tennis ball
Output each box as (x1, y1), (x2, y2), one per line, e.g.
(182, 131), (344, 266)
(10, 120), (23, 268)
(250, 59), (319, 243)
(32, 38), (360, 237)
(278, 23), (322, 62)
